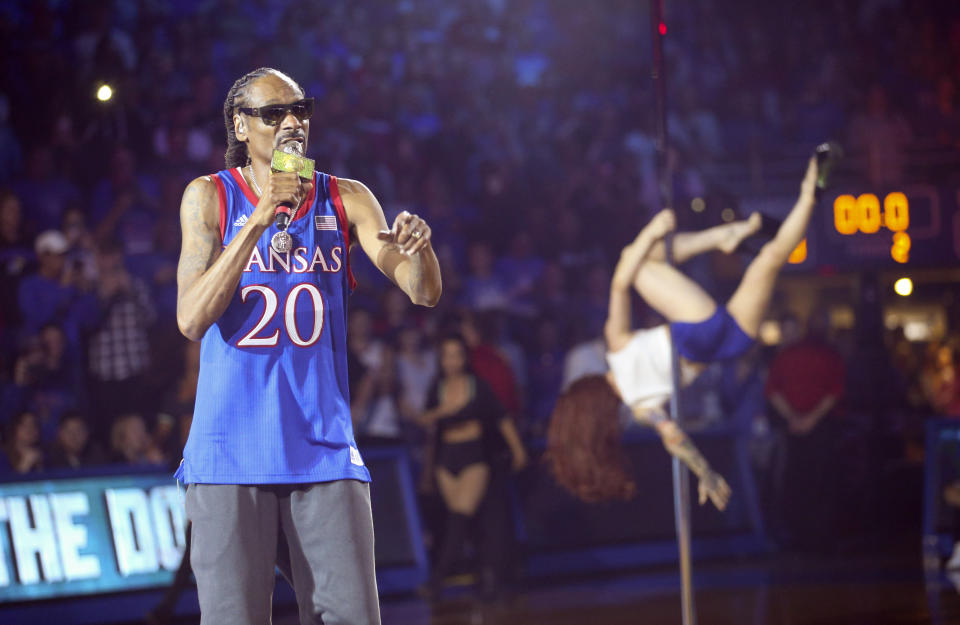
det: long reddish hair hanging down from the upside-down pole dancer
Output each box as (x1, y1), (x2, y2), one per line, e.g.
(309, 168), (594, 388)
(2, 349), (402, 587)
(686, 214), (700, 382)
(544, 375), (637, 502)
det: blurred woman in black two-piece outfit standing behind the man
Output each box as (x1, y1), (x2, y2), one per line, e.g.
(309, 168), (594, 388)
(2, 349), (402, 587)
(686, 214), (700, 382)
(421, 335), (527, 591)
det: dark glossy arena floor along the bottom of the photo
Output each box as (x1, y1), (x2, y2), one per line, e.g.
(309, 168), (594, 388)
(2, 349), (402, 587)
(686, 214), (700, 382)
(274, 552), (960, 625)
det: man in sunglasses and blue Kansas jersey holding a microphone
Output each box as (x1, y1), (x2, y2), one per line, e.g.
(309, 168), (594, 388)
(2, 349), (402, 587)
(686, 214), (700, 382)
(176, 68), (441, 625)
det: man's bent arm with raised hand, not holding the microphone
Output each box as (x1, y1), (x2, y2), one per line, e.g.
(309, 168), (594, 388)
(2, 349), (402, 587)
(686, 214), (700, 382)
(337, 178), (442, 306)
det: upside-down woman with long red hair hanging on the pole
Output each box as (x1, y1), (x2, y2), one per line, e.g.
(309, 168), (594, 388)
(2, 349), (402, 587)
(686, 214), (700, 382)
(545, 157), (817, 510)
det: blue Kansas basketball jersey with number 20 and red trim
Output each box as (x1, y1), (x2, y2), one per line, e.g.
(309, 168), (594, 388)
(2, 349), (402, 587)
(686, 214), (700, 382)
(176, 169), (370, 484)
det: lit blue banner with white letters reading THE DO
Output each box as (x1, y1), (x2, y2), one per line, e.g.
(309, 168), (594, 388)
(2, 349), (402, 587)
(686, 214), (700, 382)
(0, 472), (186, 602)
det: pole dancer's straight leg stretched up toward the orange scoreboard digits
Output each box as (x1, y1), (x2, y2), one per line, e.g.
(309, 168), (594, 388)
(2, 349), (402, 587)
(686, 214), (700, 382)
(727, 158), (817, 337)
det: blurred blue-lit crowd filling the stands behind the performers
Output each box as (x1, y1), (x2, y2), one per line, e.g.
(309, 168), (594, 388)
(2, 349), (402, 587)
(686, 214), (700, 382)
(0, 0), (960, 556)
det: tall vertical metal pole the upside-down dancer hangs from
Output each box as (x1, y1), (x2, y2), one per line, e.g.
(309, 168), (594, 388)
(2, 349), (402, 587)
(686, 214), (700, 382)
(650, 0), (697, 625)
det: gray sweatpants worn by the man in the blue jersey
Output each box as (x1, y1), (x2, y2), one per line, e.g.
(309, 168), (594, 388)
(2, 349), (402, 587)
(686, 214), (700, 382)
(186, 480), (380, 625)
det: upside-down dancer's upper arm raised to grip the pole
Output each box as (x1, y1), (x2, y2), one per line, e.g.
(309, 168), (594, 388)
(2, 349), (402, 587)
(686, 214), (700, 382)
(603, 209), (677, 352)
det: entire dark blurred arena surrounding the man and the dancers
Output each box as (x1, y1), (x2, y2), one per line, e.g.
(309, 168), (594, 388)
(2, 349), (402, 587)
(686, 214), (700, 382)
(0, 0), (960, 625)
